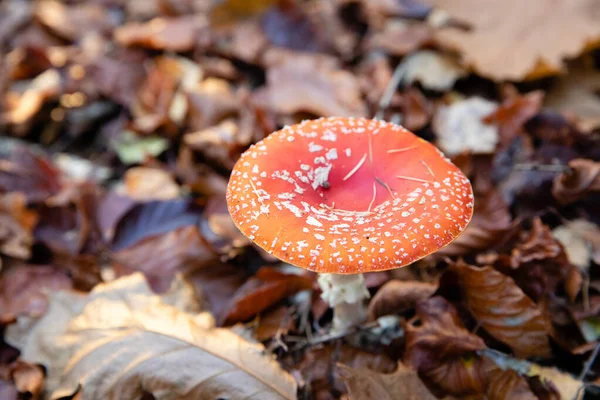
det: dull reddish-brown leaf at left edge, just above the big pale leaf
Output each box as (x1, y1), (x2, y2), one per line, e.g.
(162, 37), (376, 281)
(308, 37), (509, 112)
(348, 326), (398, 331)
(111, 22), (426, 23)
(0, 265), (72, 323)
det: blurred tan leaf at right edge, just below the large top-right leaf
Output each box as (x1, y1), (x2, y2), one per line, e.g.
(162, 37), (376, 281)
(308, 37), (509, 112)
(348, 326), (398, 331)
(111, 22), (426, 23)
(545, 66), (600, 131)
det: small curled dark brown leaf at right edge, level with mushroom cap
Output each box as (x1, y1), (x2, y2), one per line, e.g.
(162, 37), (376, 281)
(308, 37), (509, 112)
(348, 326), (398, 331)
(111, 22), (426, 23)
(552, 158), (600, 204)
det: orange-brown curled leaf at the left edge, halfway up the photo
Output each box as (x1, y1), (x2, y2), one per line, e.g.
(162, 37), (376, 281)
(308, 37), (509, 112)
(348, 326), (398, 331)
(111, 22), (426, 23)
(0, 192), (37, 260)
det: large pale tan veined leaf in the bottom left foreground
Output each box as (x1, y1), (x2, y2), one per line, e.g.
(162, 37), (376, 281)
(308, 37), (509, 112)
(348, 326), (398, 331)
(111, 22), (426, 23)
(7, 274), (296, 400)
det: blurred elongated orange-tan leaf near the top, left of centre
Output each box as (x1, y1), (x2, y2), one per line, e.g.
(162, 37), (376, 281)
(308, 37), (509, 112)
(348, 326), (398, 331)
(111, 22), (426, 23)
(114, 16), (207, 52)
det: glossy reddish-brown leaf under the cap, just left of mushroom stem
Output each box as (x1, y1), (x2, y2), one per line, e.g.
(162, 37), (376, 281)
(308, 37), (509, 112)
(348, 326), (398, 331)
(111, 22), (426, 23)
(220, 267), (313, 325)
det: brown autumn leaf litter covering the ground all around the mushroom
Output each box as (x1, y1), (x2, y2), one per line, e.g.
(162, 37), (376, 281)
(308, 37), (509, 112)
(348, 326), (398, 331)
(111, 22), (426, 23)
(0, 0), (600, 400)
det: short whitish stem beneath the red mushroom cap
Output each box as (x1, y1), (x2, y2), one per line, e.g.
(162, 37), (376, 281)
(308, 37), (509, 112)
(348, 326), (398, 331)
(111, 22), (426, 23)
(319, 274), (369, 332)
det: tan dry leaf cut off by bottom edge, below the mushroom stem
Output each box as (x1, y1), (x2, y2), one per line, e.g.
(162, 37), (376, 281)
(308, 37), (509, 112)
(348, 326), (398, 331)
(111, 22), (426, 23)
(338, 362), (437, 400)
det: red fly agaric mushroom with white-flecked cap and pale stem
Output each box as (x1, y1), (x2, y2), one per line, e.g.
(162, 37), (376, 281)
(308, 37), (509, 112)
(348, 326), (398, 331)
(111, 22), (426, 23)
(227, 118), (473, 331)
